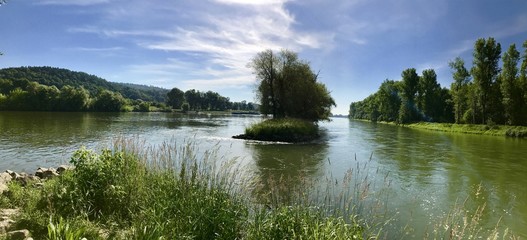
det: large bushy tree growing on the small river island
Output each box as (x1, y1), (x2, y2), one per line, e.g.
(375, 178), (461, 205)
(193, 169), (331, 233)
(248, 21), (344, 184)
(249, 50), (336, 122)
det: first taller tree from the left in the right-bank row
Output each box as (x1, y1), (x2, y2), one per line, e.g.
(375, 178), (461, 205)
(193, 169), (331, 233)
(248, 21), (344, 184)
(398, 68), (419, 123)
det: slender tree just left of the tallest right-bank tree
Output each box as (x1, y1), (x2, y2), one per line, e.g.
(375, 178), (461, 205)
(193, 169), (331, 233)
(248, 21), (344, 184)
(448, 57), (470, 123)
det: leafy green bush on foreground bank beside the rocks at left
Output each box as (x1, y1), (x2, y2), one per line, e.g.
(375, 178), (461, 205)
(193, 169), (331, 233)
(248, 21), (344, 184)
(49, 149), (146, 221)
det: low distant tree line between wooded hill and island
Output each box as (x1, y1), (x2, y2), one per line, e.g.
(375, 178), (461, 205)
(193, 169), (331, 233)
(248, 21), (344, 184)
(167, 88), (258, 111)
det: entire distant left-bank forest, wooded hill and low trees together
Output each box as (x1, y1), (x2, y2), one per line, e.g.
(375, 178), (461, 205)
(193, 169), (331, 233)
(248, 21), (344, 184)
(0, 67), (255, 112)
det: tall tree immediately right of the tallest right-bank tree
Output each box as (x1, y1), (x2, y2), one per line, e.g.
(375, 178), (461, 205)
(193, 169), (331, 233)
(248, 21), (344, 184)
(500, 44), (523, 125)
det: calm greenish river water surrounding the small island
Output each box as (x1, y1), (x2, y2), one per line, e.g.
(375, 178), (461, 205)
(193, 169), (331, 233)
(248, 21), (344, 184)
(0, 112), (527, 239)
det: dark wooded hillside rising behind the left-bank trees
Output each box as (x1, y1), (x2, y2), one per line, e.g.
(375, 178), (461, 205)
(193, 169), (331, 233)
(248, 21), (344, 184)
(0, 67), (168, 102)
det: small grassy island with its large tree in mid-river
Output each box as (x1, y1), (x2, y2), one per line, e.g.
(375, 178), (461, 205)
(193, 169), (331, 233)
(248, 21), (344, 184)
(233, 50), (336, 143)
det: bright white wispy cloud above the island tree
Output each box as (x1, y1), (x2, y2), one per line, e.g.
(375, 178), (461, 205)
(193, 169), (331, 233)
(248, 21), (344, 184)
(65, 0), (333, 88)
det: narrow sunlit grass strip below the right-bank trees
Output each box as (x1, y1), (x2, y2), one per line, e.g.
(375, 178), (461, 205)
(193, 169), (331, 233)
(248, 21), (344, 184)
(404, 122), (527, 138)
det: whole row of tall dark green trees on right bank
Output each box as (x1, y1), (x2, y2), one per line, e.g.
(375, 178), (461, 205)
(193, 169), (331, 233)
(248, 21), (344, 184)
(349, 38), (527, 125)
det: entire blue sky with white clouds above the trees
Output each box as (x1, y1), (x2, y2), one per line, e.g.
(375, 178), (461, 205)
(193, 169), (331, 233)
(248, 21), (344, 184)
(0, 0), (527, 114)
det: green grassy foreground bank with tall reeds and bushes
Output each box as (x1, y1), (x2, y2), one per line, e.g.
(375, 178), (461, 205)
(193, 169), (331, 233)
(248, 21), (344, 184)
(0, 141), (368, 239)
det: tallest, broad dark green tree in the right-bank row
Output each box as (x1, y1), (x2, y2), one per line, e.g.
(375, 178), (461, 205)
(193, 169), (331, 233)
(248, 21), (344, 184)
(471, 38), (501, 124)
